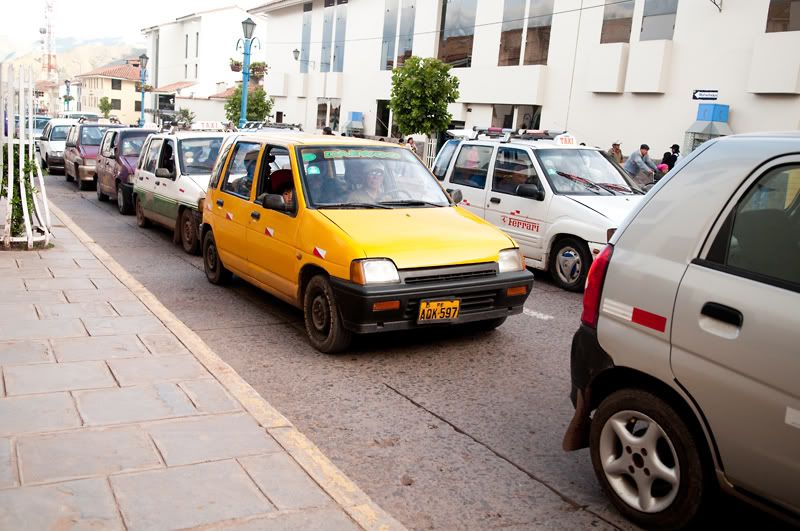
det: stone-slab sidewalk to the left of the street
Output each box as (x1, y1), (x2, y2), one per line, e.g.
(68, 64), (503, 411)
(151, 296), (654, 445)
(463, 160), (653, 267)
(0, 209), (402, 530)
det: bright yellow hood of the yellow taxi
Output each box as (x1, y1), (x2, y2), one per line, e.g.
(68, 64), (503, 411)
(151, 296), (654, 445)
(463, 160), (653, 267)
(320, 207), (515, 269)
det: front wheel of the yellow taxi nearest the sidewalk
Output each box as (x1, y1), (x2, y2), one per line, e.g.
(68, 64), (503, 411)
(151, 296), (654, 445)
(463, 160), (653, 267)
(303, 275), (353, 354)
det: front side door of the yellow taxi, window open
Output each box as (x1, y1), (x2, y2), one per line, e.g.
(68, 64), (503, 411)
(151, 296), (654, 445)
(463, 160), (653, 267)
(246, 145), (305, 299)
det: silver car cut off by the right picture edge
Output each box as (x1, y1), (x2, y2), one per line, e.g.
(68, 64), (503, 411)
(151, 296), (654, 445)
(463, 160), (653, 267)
(564, 133), (800, 529)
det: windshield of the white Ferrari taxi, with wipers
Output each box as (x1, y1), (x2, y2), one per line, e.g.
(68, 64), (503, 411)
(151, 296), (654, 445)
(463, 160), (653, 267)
(536, 149), (638, 195)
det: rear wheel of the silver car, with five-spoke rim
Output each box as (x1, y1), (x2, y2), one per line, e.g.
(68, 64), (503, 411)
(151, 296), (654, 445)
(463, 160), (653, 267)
(589, 389), (709, 529)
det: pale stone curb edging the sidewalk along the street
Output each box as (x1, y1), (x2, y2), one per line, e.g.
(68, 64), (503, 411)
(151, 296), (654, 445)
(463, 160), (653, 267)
(48, 201), (405, 531)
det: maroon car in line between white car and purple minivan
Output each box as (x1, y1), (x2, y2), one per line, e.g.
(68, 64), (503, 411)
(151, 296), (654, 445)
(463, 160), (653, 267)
(64, 122), (122, 190)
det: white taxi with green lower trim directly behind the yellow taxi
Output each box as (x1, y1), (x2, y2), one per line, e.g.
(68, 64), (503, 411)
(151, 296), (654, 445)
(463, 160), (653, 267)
(133, 132), (227, 254)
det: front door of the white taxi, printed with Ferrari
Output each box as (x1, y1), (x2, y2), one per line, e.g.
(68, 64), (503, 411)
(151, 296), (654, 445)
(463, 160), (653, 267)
(486, 146), (552, 260)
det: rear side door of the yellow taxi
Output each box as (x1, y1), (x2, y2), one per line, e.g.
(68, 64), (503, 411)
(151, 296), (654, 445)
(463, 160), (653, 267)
(212, 141), (261, 275)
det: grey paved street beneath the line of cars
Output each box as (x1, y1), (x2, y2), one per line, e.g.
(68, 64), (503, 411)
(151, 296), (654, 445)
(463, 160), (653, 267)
(43, 176), (788, 529)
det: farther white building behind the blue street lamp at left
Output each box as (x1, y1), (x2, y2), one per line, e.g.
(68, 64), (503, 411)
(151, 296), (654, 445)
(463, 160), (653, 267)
(142, 6), (266, 121)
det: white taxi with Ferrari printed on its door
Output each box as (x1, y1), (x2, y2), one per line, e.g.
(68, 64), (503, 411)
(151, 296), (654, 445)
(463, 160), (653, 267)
(433, 128), (643, 291)
